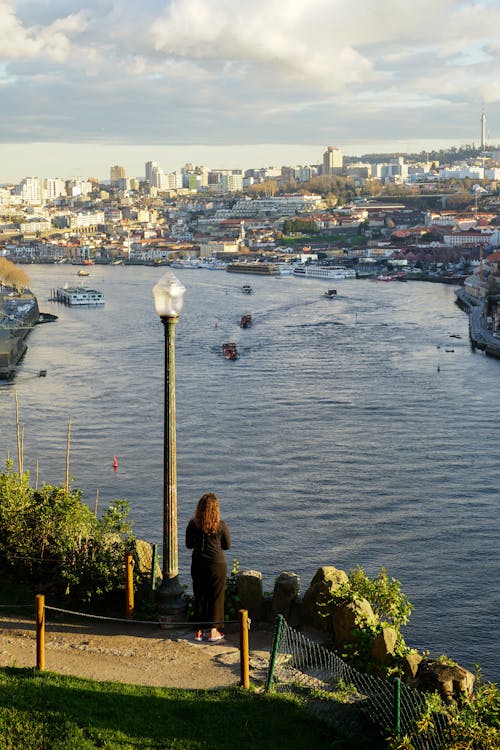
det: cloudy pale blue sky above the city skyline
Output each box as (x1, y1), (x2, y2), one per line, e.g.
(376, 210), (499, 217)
(0, 0), (500, 182)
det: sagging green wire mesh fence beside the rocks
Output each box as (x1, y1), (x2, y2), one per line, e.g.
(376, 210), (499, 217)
(266, 617), (446, 750)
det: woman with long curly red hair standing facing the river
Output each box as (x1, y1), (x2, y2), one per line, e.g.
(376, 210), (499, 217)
(186, 492), (231, 642)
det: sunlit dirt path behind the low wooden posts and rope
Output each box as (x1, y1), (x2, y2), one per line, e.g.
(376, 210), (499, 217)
(0, 613), (272, 689)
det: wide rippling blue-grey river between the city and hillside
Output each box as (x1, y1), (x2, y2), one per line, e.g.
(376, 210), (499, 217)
(0, 265), (500, 680)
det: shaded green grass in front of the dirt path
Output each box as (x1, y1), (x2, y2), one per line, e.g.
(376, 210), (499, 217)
(0, 667), (349, 750)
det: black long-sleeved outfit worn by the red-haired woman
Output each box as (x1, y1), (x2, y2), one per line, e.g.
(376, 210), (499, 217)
(186, 519), (231, 627)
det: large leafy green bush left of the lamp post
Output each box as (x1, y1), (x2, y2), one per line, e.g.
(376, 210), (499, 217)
(0, 461), (133, 602)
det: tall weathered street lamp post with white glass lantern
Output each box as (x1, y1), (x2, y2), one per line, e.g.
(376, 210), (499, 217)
(153, 271), (186, 615)
